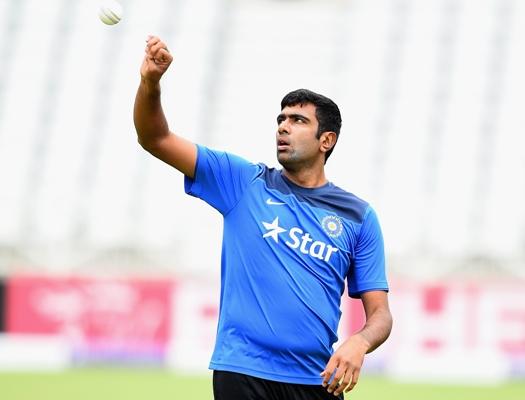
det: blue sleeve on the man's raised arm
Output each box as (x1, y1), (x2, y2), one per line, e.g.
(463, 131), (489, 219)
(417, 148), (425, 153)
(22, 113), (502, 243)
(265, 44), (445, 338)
(184, 145), (262, 215)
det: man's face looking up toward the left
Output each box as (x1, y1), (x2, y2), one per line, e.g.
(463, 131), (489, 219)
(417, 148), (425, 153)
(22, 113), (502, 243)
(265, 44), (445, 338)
(276, 104), (324, 171)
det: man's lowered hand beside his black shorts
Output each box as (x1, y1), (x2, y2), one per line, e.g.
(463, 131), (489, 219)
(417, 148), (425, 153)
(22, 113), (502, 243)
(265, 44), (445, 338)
(321, 335), (368, 396)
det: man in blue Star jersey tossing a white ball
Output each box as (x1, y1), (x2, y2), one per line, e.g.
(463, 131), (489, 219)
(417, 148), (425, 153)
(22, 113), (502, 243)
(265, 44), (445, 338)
(134, 37), (392, 400)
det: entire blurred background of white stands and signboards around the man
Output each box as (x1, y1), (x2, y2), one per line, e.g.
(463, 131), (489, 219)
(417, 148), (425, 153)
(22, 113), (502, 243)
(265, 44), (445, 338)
(0, 0), (525, 399)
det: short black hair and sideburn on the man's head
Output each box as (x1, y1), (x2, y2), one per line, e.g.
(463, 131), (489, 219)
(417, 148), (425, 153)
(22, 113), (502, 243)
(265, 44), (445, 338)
(281, 89), (342, 163)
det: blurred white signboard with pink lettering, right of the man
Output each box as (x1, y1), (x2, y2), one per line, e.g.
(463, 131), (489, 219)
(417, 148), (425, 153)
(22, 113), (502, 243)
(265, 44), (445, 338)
(340, 281), (525, 384)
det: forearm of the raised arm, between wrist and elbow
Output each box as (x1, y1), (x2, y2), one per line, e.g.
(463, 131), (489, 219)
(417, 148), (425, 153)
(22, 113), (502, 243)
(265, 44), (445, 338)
(133, 78), (170, 149)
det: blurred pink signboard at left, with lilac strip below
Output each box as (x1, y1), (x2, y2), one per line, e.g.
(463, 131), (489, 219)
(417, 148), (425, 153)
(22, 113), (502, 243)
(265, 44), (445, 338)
(6, 277), (173, 363)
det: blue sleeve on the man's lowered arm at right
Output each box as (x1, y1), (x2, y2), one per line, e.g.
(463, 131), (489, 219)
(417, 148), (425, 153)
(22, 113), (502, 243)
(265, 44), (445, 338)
(347, 206), (388, 298)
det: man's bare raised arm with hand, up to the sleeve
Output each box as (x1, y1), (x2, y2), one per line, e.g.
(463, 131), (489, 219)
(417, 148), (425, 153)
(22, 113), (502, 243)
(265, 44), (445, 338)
(133, 36), (197, 178)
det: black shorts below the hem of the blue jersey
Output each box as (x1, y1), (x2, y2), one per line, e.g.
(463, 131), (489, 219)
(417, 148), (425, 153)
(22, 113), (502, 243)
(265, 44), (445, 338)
(213, 371), (344, 400)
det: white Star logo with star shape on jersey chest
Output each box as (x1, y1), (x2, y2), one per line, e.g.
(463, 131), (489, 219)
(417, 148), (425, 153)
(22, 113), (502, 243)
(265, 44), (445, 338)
(262, 217), (339, 262)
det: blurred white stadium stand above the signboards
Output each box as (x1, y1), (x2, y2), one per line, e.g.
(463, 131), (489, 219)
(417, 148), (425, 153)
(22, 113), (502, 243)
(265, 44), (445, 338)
(0, 0), (525, 279)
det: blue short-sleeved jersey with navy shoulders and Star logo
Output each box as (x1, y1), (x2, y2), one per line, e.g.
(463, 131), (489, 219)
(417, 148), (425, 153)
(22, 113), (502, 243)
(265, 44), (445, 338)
(185, 146), (388, 384)
